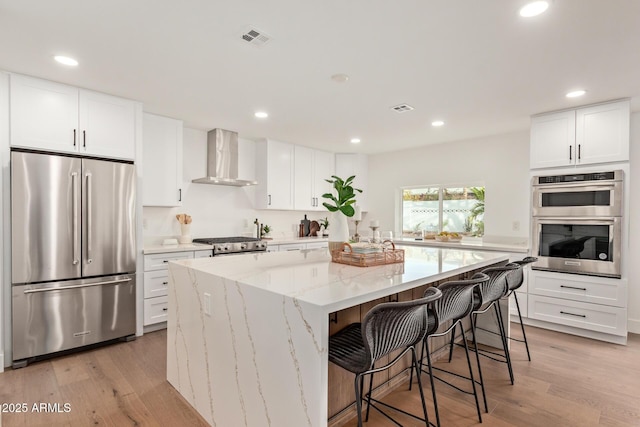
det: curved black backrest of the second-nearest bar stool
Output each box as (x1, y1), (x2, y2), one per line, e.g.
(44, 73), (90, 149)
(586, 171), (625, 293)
(427, 273), (489, 334)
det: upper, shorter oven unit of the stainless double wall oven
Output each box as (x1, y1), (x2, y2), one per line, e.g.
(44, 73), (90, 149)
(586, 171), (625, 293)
(532, 170), (623, 217)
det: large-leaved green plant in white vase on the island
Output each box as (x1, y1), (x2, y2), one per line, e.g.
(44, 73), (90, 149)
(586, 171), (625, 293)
(322, 175), (362, 250)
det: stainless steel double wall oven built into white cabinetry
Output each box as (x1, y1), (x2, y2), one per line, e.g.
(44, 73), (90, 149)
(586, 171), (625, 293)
(532, 170), (624, 278)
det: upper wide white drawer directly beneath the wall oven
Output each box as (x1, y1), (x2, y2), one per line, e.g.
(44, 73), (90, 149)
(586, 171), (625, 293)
(529, 271), (627, 308)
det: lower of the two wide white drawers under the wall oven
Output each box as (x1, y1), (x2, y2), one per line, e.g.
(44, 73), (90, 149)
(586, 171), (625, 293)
(527, 294), (627, 336)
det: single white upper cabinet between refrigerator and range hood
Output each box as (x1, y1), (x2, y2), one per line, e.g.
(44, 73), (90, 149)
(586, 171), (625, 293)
(142, 113), (183, 206)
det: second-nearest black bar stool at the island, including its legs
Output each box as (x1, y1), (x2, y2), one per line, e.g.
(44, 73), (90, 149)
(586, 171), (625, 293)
(412, 273), (489, 426)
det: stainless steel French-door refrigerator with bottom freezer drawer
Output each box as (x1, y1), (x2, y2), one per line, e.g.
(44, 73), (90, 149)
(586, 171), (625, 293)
(11, 151), (136, 367)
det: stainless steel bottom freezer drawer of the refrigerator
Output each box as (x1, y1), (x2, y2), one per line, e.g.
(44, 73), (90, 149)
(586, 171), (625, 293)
(12, 275), (136, 361)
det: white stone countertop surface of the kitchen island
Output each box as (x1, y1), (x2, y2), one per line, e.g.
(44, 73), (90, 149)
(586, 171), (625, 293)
(172, 246), (508, 313)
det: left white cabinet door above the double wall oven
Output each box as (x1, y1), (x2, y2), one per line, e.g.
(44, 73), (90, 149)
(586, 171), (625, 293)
(529, 111), (577, 169)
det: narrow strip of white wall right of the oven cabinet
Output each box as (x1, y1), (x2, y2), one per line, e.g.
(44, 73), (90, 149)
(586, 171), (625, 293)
(627, 113), (640, 334)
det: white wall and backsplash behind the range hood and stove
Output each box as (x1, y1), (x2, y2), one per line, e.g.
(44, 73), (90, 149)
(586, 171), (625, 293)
(143, 128), (336, 243)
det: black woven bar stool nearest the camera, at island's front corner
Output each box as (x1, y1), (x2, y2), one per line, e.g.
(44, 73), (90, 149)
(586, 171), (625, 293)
(329, 288), (442, 427)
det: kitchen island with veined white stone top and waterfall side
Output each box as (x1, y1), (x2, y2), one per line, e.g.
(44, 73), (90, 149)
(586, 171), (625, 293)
(167, 247), (508, 427)
